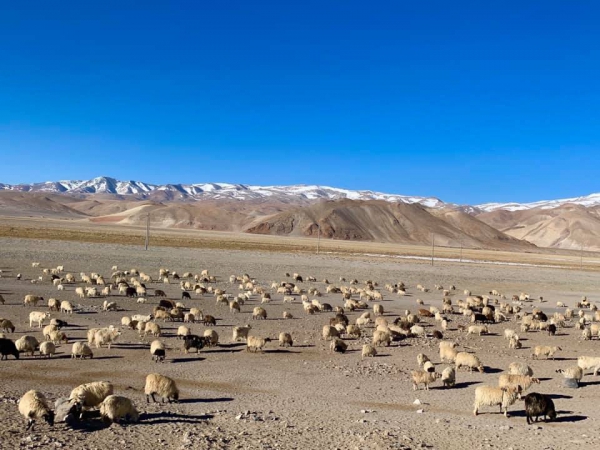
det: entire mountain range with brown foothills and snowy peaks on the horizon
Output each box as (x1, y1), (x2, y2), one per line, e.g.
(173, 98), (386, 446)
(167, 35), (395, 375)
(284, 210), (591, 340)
(0, 177), (600, 250)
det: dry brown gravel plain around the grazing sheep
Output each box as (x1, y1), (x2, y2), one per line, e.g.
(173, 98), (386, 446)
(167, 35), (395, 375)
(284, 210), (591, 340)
(0, 238), (600, 449)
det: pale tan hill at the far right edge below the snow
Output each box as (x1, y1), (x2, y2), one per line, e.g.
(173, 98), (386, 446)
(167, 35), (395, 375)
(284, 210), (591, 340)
(477, 204), (600, 250)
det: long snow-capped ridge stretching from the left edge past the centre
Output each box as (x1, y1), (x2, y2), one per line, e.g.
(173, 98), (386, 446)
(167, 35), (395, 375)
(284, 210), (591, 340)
(0, 177), (445, 208)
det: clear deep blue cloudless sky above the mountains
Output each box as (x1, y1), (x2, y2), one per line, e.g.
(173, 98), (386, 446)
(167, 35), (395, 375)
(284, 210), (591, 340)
(0, 0), (600, 203)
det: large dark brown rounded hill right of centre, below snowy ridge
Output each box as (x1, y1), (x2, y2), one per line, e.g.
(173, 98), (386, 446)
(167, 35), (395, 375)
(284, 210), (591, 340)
(246, 200), (532, 249)
